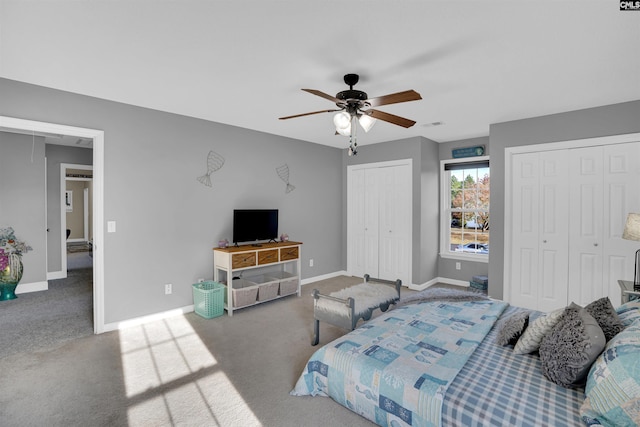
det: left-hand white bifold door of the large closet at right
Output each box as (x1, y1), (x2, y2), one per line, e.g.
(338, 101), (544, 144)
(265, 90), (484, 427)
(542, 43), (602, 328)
(510, 150), (569, 311)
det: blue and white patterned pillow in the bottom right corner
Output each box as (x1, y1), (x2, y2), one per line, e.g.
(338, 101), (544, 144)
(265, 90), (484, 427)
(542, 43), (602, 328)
(580, 322), (640, 426)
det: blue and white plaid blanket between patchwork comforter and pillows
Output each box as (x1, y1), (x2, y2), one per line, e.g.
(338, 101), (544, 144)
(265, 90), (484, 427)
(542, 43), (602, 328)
(442, 307), (585, 427)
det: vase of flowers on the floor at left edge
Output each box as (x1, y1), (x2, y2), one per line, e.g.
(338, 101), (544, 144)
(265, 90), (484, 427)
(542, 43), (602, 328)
(0, 227), (31, 301)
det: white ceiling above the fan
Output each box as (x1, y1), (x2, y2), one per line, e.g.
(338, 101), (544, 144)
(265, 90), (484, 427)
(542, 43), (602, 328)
(0, 0), (640, 148)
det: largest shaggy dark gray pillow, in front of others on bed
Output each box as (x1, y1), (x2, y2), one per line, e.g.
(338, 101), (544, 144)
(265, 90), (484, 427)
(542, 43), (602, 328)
(540, 303), (606, 388)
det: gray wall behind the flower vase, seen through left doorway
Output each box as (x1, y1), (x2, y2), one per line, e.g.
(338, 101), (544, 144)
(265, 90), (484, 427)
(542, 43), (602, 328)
(0, 130), (47, 291)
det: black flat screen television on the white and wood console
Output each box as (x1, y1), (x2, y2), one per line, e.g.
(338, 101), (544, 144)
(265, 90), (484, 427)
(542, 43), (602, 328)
(233, 209), (278, 244)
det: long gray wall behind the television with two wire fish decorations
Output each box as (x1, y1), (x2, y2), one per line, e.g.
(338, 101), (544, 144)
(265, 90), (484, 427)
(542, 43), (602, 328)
(0, 79), (344, 323)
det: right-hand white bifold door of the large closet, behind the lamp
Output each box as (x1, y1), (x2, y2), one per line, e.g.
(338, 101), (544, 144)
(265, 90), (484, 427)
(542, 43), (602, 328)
(569, 143), (640, 306)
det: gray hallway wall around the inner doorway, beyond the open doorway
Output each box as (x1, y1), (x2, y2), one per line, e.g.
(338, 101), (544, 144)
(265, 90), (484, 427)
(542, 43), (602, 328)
(45, 144), (93, 273)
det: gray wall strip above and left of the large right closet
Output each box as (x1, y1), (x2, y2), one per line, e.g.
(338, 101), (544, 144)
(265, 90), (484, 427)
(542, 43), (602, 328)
(489, 100), (640, 298)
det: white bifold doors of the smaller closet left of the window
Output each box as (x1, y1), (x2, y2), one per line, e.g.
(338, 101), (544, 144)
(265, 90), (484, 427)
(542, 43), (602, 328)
(347, 164), (412, 285)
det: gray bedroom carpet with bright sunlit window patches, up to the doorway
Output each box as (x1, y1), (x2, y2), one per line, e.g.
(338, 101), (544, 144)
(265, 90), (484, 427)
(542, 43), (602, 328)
(0, 277), (470, 427)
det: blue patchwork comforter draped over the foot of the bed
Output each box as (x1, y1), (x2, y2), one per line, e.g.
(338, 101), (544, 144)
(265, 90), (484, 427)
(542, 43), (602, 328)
(291, 301), (508, 427)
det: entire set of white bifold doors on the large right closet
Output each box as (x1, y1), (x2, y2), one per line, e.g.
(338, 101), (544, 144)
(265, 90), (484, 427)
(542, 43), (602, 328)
(505, 142), (640, 311)
